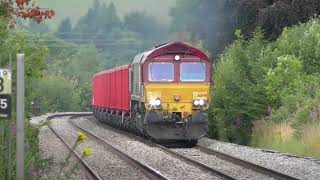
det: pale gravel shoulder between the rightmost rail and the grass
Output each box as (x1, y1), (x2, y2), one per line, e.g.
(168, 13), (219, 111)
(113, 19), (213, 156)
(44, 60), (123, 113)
(198, 138), (320, 180)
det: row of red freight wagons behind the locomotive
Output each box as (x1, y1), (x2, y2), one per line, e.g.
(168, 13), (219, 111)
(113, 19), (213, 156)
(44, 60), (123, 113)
(92, 65), (130, 112)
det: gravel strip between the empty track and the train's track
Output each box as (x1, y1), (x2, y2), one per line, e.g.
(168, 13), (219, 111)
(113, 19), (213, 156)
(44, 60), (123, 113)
(73, 117), (220, 179)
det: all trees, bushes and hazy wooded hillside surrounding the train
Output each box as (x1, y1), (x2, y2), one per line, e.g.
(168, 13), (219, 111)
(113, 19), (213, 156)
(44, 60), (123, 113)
(0, 0), (320, 179)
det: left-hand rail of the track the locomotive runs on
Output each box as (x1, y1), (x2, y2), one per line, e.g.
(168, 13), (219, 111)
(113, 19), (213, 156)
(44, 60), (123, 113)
(75, 115), (235, 180)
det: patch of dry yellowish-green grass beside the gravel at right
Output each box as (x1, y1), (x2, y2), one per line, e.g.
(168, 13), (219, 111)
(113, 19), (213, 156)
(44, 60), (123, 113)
(252, 121), (320, 159)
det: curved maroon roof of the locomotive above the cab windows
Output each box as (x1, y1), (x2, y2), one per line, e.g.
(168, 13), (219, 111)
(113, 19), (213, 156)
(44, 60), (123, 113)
(132, 42), (209, 64)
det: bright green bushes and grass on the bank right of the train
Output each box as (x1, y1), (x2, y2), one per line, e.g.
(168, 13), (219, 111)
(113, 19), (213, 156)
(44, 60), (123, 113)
(210, 20), (320, 157)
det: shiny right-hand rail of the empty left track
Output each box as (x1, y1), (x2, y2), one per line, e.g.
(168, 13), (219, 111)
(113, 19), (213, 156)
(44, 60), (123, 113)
(69, 115), (168, 180)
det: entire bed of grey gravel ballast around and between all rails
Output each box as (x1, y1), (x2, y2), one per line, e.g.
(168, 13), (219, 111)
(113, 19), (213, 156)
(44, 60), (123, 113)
(35, 113), (320, 180)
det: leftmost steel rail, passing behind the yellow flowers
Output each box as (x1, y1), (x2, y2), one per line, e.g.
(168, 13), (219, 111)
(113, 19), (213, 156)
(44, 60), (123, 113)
(47, 119), (103, 180)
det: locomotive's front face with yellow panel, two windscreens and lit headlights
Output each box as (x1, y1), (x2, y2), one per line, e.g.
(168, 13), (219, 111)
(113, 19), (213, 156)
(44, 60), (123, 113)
(144, 54), (211, 142)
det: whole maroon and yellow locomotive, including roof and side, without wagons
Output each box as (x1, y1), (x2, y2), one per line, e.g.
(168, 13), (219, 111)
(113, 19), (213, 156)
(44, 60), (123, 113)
(130, 42), (212, 144)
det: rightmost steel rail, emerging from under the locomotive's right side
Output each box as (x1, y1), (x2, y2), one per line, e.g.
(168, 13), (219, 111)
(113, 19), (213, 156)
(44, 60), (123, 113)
(194, 146), (298, 180)
